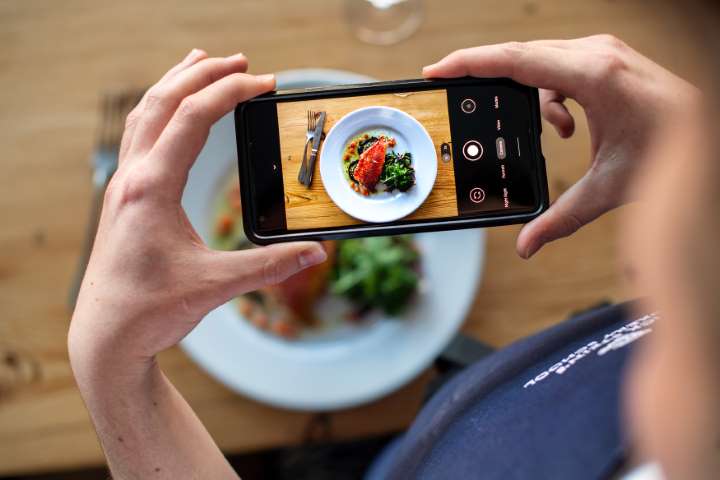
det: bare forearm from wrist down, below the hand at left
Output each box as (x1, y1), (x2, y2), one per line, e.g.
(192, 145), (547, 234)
(73, 348), (238, 480)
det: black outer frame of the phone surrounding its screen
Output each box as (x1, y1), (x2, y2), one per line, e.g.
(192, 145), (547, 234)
(235, 77), (549, 245)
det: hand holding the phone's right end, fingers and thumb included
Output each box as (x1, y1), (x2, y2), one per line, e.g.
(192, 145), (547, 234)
(423, 35), (699, 258)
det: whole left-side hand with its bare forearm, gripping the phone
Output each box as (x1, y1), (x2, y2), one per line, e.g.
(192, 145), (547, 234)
(68, 49), (326, 479)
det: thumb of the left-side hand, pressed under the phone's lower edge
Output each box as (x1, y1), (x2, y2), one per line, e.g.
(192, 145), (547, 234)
(207, 242), (327, 298)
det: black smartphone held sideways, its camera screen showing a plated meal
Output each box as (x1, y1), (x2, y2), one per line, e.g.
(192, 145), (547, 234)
(235, 78), (548, 245)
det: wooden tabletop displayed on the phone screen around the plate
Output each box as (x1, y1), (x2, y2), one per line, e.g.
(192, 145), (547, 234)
(278, 90), (458, 230)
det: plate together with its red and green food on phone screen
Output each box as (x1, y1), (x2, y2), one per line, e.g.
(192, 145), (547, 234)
(320, 106), (439, 223)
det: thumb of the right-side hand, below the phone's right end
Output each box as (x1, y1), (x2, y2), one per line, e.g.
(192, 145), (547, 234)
(516, 171), (616, 259)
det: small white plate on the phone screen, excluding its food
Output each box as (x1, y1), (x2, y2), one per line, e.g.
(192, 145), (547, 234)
(320, 107), (437, 223)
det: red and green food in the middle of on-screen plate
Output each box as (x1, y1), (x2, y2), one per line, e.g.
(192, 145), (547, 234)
(342, 131), (415, 196)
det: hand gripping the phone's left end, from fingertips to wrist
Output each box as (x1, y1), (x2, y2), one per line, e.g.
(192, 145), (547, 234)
(69, 50), (325, 378)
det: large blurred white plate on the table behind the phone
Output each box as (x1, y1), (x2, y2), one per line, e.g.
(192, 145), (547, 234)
(181, 71), (485, 410)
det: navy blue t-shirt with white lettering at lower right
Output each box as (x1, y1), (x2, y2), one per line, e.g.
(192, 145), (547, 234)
(367, 305), (657, 480)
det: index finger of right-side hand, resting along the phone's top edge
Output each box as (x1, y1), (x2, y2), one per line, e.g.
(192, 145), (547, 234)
(423, 41), (591, 98)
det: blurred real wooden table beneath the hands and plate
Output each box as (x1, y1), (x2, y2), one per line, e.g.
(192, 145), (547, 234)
(0, 0), (704, 475)
